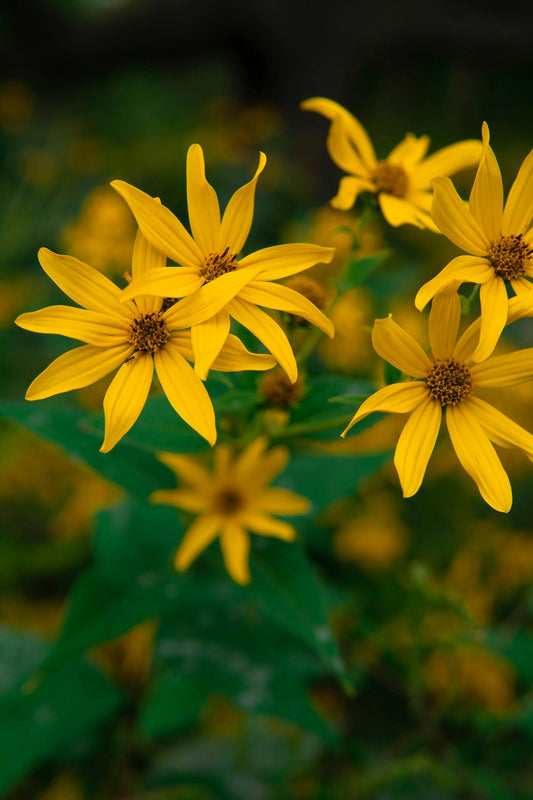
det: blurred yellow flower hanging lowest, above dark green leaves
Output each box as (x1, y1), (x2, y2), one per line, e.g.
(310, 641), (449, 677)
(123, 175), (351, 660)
(150, 437), (310, 584)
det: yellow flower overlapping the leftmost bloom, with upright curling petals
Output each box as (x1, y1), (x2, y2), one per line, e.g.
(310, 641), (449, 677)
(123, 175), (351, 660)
(111, 144), (335, 383)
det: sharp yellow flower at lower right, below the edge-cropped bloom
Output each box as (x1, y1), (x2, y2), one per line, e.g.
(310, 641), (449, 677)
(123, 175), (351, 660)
(342, 291), (533, 512)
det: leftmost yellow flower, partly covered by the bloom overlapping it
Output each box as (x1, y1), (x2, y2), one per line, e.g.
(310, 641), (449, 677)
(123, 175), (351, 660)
(15, 231), (276, 453)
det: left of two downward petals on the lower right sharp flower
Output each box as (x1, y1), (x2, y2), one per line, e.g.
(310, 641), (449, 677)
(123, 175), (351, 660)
(394, 397), (442, 497)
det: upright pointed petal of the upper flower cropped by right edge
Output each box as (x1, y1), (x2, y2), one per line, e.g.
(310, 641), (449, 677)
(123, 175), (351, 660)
(468, 122), (503, 241)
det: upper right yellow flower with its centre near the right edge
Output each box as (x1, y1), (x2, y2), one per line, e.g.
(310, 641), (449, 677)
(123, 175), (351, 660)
(415, 122), (533, 361)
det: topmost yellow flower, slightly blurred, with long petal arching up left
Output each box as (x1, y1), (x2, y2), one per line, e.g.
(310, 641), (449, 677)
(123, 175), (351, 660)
(301, 97), (481, 232)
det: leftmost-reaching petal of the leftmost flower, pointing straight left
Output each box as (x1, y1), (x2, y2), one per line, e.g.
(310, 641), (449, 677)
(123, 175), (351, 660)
(15, 306), (128, 347)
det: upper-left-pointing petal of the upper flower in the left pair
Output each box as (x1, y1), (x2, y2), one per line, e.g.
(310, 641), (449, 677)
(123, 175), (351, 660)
(111, 181), (204, 267)
